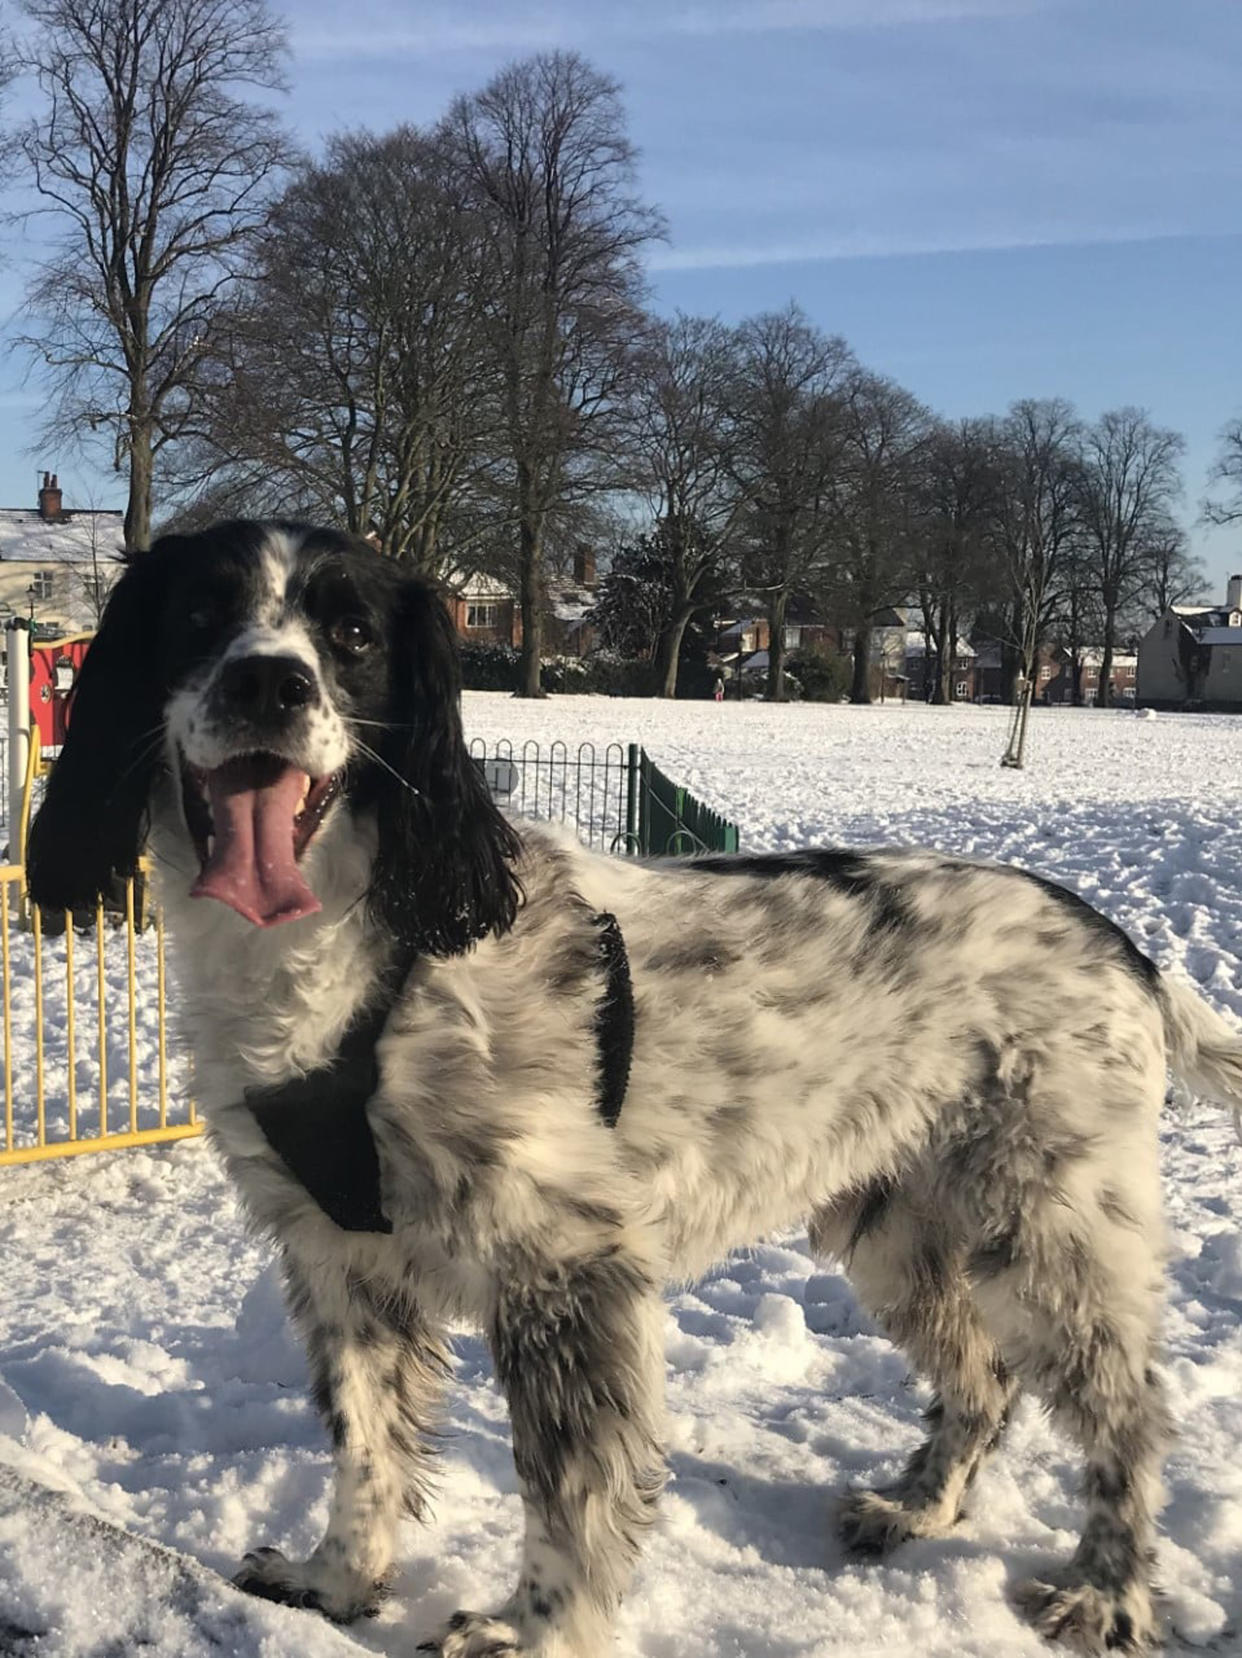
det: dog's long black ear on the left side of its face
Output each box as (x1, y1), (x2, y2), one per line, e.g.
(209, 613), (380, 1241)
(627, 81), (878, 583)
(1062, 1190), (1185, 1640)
(27, 552), (164, 910)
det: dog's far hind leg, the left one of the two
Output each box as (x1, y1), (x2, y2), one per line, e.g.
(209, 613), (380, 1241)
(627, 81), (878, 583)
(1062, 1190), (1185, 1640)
(811, 1184), (1016, 1554)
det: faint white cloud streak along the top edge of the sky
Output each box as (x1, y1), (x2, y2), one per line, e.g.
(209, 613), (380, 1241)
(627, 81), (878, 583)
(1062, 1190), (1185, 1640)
(292, 0), (1046, 60)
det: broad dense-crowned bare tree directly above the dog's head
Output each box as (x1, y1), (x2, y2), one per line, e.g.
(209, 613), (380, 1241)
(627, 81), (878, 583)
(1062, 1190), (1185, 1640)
(174, 128), (497, 569)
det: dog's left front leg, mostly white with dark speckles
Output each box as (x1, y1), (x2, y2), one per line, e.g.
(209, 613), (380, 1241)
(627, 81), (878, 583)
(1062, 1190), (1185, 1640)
(234, 1257), (446, 1623)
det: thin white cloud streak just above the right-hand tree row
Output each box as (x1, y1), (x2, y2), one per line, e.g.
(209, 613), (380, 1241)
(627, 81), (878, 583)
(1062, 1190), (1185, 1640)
(647, 225), (1212, 275)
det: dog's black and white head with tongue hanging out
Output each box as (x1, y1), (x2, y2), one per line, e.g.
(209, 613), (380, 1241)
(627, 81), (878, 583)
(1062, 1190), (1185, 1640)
(28, 521), (519, 955)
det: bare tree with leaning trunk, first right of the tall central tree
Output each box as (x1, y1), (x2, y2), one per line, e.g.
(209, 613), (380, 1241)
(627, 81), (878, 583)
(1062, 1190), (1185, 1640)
(628, 315), (746, 696)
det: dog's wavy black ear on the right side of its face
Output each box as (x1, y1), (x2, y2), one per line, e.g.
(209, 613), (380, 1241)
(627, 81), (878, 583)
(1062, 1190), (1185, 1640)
(370, 577), (522, 957)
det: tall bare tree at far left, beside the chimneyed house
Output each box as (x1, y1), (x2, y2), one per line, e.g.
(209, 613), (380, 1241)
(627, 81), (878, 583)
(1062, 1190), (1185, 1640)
(13, 0), (289, 547)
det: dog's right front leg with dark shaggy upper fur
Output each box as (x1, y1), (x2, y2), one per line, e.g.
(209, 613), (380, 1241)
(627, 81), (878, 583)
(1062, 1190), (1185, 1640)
(425, 1247), (663, 1658)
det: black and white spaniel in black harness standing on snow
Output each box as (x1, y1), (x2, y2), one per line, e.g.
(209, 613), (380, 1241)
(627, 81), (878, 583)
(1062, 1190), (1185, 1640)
(28, 522), (1242, 1658)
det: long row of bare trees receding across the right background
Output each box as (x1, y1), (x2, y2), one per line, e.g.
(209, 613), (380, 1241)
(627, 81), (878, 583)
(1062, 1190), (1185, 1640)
(619, 319), (1197, 700)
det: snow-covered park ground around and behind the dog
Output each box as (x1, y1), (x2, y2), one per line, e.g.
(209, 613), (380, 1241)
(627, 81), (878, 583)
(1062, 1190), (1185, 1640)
(0, 695), (1242, 1658)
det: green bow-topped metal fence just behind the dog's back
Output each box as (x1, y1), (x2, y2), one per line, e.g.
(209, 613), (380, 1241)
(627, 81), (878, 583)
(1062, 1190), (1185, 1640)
(471, 738), (738, 857)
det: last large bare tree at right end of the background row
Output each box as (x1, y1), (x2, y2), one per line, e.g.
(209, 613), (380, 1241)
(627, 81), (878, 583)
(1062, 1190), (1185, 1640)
(1079, 408), (1186, 708)
